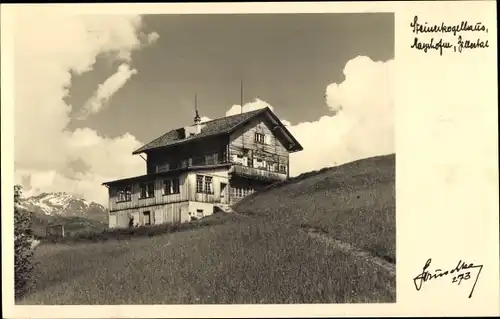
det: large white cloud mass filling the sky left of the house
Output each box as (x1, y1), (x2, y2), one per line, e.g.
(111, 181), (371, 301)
(14, 8), (155, 204)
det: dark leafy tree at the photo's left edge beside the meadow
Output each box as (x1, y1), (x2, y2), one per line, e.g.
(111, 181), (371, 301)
(14, 185), (34, 299)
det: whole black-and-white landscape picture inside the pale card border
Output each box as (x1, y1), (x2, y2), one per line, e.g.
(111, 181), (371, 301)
(9, 13), (396, 305)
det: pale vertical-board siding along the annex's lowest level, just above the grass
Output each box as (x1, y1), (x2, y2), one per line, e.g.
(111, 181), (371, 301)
(109, 201), (190, 228)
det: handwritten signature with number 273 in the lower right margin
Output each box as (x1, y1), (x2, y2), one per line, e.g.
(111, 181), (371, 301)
(413, 258), (483, 298)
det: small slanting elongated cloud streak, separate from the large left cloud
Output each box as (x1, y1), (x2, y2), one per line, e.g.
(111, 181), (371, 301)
(79, 63), (137, 119)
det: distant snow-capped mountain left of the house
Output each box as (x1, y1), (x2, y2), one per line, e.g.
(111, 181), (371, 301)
(19, 192), (108, 222)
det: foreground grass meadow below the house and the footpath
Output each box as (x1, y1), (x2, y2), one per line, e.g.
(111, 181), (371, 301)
(18, 218), (394, 304)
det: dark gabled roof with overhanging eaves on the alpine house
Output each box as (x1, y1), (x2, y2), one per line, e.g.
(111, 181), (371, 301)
(132, 107), (302, 154)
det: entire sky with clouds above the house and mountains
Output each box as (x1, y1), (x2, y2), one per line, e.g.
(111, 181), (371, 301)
(14, 9), (394, 205)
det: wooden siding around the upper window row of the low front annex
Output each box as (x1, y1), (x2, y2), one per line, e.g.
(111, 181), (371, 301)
(109, 173), (188, 211)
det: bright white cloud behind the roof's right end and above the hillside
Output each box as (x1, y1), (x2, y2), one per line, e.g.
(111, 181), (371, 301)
(226, 56), (394, 176)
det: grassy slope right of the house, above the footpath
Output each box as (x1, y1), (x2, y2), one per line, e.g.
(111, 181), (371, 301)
(235, 155), (396, 262)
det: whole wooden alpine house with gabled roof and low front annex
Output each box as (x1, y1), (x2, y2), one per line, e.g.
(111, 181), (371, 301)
(103, 108), (302, 228)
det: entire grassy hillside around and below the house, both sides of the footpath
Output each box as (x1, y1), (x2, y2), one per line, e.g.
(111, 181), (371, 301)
(21, 156), (395, 304)
